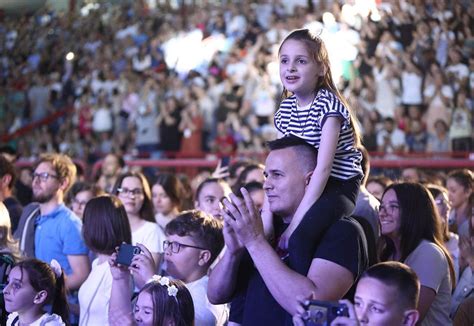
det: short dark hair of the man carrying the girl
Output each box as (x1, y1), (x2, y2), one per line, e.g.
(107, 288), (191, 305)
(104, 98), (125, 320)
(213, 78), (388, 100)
(267, 135), (318, 173)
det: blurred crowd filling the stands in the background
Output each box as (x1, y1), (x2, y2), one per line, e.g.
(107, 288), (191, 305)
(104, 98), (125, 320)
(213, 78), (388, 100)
(0, 1), (474, 162)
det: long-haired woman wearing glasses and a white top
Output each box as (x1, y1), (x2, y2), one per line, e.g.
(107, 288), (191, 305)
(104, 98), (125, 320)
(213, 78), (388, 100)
(112, 172), (166, 263)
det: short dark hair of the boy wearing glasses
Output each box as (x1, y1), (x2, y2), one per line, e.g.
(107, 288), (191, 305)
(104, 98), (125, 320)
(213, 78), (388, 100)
(165, 210), (224, 265)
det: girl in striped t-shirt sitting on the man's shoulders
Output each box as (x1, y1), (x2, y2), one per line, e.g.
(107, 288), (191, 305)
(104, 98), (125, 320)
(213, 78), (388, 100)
(270, 29), (363, 274)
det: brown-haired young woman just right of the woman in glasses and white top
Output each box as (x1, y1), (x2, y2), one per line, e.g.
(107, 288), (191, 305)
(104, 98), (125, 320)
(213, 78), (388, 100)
(151, 173), (183, 230)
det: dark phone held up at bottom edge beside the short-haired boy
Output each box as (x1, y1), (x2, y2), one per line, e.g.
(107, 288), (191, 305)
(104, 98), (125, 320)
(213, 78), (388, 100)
(303, 300), (349, 326)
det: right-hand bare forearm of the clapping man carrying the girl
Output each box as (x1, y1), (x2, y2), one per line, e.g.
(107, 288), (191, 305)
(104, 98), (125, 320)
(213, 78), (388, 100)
(247, 236), (316, 315)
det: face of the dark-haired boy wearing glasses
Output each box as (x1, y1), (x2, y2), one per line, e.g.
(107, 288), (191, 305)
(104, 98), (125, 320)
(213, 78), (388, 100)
(164, 234), (205, 283)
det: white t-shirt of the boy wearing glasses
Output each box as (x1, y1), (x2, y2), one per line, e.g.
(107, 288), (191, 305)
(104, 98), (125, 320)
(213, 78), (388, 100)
(186, 275), (229, 326)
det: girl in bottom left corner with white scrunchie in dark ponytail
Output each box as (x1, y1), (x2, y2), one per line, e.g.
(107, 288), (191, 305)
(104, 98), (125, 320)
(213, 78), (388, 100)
(3, 259), (69, 326)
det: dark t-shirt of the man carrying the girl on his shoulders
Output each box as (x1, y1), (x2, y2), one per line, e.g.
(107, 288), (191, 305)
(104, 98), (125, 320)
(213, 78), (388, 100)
(237, 218), (367, 326)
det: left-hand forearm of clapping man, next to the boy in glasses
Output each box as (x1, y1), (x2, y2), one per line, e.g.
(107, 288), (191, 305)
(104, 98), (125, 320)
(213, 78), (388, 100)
(207, 250), (242, 304)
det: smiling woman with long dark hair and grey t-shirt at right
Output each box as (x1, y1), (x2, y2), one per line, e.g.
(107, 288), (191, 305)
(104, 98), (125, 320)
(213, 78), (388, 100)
(379, 182), (455, 326)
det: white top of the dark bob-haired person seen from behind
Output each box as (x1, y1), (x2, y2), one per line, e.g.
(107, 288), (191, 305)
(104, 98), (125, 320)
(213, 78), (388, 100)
(79, 259), (112, 326)
